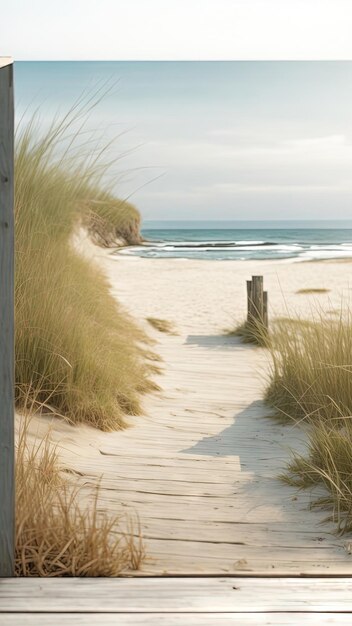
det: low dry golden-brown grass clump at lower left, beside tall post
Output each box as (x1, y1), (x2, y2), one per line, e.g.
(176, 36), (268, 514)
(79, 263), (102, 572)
(15, 418), (144, 576)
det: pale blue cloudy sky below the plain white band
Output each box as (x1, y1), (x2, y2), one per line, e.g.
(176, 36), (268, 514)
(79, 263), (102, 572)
(15, 62), (352, 220)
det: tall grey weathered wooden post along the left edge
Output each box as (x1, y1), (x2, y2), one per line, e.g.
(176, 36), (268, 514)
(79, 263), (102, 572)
(0, 57), (15, 577)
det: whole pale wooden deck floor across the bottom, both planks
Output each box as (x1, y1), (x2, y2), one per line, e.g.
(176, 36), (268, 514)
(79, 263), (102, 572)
(0, 577), (352, 626)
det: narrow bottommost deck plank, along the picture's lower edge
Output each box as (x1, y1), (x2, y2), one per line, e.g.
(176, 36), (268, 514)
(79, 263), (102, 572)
(1, 612), (352, 626)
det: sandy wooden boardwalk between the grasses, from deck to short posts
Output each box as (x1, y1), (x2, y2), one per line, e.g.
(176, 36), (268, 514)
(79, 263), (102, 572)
(33, 336), (352, 575)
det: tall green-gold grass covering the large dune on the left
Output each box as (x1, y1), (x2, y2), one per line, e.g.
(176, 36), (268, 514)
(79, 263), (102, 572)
(15, 116), (155, 430)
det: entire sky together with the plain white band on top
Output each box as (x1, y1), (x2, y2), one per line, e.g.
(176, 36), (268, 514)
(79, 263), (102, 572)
(4, 0), (352, 220)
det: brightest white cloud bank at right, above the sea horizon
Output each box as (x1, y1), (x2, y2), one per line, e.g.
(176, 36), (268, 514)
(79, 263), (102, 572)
(144, 135), (352, 188)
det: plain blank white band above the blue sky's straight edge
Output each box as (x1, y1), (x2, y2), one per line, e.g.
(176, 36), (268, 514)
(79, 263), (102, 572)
(0, 0), (352, 60)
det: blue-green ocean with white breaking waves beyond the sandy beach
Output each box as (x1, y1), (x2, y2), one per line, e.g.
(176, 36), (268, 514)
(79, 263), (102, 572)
(117, 222), (352, 261)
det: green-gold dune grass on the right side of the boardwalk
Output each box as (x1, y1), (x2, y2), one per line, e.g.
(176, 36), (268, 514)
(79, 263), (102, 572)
(266, 312), (352, 532)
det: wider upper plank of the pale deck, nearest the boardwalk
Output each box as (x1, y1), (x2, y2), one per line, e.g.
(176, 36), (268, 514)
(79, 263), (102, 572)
(0, 577), (352, 614)
